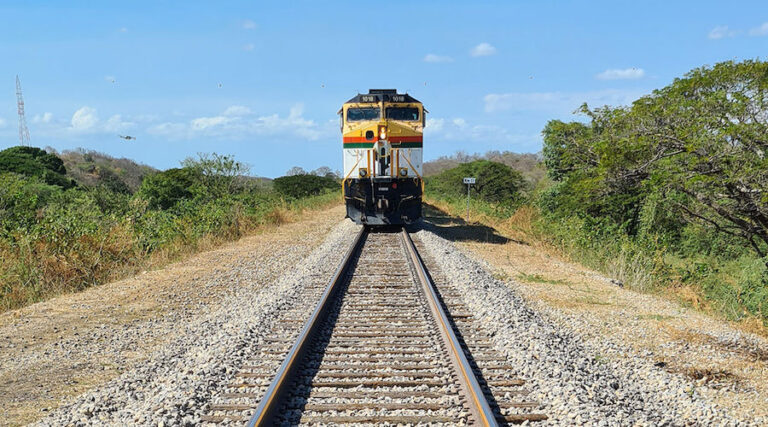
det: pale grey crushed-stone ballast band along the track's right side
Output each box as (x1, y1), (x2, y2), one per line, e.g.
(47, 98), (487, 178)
(414, 224), (765, 425)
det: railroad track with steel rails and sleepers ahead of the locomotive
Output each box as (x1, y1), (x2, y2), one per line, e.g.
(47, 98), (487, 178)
(202, 229), (546, 426)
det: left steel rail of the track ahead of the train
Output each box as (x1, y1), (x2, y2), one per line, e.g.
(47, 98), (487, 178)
(248, 227), (367, 427)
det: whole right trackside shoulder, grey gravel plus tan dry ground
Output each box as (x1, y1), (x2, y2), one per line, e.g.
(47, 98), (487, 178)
(415, 210), (768, 425)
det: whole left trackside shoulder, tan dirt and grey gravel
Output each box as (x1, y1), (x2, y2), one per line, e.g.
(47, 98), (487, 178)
(0, 207), (351, 425)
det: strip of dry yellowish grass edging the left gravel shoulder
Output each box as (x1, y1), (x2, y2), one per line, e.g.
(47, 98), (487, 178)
(0, 197), (339, 312)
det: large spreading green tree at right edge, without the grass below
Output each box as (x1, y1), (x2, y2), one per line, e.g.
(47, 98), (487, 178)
(544, 60), (768, 256)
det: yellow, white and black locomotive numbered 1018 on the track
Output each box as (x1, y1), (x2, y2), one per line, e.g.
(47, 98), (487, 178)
(338, 89), (428, 226)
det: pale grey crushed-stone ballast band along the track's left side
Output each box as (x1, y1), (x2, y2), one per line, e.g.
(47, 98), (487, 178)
(38, 221), (358, 426)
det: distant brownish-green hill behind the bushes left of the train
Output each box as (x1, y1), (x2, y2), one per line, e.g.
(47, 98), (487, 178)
(46, 147), (157, 193)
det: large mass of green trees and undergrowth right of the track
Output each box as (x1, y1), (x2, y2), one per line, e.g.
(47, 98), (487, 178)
(536, 61), (768, 319)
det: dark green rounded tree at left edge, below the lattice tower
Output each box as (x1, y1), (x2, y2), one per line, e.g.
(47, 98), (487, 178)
(0, 146), (74, 188)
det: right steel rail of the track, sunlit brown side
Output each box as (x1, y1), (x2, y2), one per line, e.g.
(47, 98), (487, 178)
(402, 231), (499, 426)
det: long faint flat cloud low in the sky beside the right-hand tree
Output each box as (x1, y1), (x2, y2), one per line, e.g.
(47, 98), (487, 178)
(483, 89), (644, 114)
